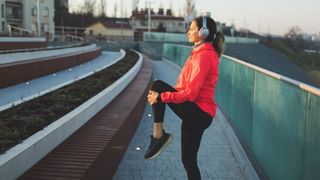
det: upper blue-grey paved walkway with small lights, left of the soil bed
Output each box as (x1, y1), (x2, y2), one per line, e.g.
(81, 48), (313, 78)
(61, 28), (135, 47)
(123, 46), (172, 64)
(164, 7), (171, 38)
(0, 52), (122, 111)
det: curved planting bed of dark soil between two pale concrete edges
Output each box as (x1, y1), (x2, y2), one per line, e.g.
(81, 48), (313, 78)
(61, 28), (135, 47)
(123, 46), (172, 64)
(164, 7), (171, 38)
(0, 50), (139, 154)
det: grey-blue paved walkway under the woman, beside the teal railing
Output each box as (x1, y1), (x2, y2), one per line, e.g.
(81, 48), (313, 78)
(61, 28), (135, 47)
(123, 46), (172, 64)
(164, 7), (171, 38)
(113, 61), (249, 180)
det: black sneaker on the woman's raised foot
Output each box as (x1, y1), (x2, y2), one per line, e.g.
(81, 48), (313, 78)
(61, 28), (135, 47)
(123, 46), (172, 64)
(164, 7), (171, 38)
(144, 131), (173, 159)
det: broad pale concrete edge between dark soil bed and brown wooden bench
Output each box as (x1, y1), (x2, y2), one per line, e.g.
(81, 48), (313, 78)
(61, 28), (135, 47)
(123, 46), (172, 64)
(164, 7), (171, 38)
(0, 49), (143, 179)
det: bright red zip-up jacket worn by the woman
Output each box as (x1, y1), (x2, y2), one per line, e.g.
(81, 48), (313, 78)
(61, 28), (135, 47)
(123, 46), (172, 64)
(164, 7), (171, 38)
(161, 43), (219, 117)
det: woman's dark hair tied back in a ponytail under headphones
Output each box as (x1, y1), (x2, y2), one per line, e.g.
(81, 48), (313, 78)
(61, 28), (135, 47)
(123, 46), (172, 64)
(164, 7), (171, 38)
(194, 16), (224, 57)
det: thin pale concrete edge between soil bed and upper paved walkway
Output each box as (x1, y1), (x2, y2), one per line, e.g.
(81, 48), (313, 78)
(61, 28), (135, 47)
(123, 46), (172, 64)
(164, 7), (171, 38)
(0, 49), (126, 112)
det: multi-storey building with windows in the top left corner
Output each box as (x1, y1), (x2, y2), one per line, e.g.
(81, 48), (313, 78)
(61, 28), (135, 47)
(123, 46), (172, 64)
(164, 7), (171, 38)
(0, 0), (55, 39)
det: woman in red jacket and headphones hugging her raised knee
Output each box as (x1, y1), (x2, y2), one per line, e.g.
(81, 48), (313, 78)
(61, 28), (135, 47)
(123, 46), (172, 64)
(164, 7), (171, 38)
(144, 17), (224, 180)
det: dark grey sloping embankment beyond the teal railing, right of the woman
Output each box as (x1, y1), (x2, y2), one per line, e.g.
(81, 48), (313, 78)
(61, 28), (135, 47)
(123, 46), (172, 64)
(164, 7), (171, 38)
(225, 43), (320, 87)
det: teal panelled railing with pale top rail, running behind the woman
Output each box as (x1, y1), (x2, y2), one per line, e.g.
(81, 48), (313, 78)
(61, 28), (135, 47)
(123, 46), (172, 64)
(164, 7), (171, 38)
(163, 44), (320, 180)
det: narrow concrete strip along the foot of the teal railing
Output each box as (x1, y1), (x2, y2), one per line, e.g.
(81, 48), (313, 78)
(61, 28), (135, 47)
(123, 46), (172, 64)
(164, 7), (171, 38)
(215, 108), (260, 180)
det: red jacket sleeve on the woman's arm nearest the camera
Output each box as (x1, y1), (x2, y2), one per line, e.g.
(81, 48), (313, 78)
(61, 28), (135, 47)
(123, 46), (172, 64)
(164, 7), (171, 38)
(161, 53), (211, 104)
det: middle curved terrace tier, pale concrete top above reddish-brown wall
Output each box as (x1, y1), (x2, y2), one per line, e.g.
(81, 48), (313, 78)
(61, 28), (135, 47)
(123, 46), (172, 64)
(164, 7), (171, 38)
(0, 45), (101, 88)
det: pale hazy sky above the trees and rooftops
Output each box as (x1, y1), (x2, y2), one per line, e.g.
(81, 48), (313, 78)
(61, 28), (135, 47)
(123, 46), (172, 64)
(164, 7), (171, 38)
(69, 0), (320, 35)
